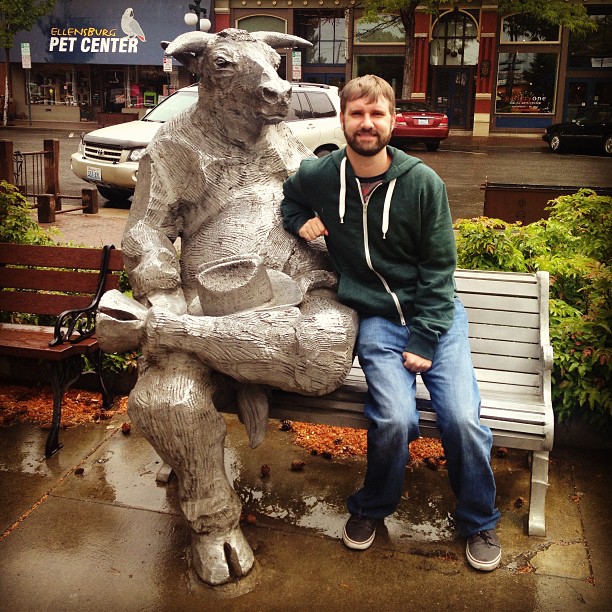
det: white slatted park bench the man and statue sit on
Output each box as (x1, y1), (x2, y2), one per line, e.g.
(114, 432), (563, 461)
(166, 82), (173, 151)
(264, 270), (554, 536)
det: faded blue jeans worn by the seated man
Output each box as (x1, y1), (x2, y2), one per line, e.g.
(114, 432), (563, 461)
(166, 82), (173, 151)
(347, 299), (500, 537)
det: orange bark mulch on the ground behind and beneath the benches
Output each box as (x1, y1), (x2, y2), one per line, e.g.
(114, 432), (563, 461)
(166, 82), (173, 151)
(0, 385), (445, 468)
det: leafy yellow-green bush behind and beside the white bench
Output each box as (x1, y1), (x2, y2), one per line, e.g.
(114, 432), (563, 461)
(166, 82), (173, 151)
(455, 189), (612, 428)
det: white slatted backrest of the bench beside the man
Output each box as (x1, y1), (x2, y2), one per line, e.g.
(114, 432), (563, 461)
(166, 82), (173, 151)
(455, 270), (550, 397)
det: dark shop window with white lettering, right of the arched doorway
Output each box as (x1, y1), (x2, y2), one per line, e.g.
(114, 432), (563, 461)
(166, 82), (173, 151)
(495, 53), (557, 113)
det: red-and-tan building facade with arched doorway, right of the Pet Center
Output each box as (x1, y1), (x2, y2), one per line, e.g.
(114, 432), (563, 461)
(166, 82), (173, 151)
(214, 0), (612, 136)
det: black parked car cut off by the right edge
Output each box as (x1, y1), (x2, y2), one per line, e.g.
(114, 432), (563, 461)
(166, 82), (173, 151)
(542, 104), (612, 155)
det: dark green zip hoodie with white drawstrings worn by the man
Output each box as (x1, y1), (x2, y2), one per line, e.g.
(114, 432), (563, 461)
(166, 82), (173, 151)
(281, 147), (456, 360)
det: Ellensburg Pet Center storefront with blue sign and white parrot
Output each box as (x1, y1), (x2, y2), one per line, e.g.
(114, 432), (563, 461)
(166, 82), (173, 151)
(2, 0), (211, 121)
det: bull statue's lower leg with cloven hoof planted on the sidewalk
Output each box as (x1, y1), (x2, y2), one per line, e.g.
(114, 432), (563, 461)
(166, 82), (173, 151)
(128, 353), (254, 585)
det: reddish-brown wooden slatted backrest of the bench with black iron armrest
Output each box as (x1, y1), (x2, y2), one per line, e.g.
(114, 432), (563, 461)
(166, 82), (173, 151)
(0, 244), (123, 316)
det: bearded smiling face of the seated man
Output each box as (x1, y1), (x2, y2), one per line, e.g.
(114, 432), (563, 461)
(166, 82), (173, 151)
(340, 98), (395, 157)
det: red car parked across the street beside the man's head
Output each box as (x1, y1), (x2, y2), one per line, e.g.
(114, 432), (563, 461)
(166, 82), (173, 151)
(392, 100), (448, 151)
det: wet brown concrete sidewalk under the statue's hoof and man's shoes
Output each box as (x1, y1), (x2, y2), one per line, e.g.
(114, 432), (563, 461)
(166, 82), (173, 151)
(0, 415), (612, 612)
